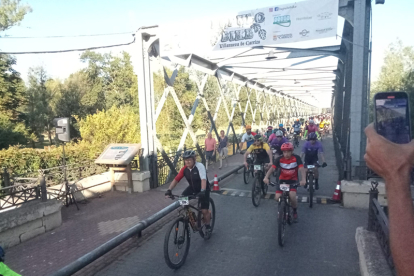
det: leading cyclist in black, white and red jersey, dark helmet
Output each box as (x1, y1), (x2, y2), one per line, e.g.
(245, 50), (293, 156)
(165, 150), (211, 238)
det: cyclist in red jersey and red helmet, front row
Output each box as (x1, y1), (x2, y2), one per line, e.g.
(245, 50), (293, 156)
(263, 142), (306, 222)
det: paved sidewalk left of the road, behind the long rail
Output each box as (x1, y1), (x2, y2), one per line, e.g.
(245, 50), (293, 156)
(6, 154), (243, 276)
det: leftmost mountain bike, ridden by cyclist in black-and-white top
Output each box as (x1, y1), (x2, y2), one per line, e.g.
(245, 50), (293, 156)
(164, 195), (216, 269)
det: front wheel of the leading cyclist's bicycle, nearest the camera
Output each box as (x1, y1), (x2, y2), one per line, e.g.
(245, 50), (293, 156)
(164, 217), (190, 269)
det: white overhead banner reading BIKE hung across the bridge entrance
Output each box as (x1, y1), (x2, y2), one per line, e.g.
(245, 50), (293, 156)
(213, 0), (339, 51)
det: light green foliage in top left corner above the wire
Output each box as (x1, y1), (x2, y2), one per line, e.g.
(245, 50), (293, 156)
(0, 0), (32, 32)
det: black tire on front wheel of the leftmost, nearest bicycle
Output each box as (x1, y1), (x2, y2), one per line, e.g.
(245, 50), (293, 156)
(164, 217), (191, 269)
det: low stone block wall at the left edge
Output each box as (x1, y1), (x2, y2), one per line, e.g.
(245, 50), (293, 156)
(0, 200), (62, 248)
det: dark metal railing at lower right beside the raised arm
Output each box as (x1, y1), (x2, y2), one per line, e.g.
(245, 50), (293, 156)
(368, 181), (394, 270)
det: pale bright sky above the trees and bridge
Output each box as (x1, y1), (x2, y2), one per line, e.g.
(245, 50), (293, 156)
(0, 0), (414, 106)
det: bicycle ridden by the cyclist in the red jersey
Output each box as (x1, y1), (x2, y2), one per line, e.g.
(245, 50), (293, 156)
(269, 182), (299, 247)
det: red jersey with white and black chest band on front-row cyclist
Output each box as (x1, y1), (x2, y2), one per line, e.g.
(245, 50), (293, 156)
(273, 154), (303, 184)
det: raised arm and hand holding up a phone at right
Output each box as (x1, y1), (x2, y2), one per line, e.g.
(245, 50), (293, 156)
(364, 124), (414, 276)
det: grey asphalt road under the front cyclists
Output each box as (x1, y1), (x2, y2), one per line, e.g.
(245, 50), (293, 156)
(96, 194), (367, 276)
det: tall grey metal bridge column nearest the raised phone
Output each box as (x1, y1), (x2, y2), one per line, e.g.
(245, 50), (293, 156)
(350, 0), (371, 170)
